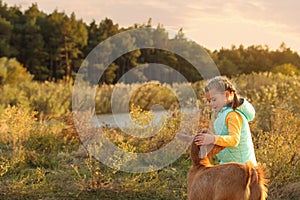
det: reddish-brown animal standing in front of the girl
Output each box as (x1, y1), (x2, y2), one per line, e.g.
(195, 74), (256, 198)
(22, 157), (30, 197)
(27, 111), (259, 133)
(188, 142), (267, 200)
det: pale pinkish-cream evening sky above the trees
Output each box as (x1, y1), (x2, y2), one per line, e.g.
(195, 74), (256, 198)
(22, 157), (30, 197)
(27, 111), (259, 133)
(3, 0), (300, 53)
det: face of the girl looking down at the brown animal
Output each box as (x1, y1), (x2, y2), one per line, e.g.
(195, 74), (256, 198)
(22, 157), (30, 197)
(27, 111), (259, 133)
(205, 89), (228, 112)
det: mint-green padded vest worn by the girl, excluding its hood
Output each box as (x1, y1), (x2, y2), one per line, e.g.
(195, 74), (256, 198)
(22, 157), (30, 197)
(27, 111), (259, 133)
(214, 107), (257, 165)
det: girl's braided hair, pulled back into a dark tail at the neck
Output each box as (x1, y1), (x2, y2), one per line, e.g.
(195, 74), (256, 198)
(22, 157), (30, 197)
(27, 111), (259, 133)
(204, 76), (242, 109)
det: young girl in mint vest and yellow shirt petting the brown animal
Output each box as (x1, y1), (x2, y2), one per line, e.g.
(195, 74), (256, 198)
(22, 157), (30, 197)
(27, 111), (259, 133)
(194, 76), (257, 165)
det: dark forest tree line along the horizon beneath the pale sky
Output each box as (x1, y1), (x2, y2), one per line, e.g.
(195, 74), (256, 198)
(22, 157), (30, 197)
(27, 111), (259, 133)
(0, 0), (300, 83)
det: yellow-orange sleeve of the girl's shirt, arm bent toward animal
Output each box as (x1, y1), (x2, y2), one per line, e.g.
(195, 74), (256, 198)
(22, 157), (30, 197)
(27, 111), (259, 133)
(215, 111), (243, 147)
